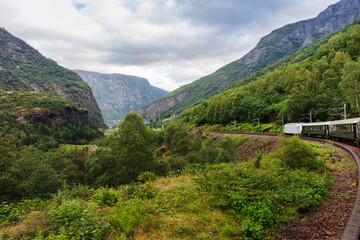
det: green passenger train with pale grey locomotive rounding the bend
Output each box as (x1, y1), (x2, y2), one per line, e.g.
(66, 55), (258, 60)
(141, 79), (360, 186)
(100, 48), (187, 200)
(283, 118), (360, 145)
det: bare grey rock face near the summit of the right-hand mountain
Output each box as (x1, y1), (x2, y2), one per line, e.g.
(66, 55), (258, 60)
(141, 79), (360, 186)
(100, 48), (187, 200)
(238, 0), (360, 65)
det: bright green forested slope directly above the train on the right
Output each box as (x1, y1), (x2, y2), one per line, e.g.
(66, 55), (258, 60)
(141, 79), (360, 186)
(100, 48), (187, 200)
(181, 21), (360, 124)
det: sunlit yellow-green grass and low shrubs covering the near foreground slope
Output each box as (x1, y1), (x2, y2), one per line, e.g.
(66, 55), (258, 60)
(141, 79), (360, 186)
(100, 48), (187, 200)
(0, 135), (332, 239)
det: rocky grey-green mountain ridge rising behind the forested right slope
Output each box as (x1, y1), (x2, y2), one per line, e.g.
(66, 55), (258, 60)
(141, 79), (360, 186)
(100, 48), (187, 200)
(136, 0), (360, 121)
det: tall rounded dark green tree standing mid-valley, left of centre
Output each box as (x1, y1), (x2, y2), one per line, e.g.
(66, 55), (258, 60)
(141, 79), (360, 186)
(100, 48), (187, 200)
(86, 113), (155, 187)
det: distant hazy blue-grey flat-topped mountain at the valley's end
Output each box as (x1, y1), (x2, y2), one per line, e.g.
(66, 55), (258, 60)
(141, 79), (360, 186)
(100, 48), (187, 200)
(74, 70), (168, 124)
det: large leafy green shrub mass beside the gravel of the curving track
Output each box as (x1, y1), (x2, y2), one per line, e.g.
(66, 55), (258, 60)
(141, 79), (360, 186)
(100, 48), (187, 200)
(197, 138), (329, 239)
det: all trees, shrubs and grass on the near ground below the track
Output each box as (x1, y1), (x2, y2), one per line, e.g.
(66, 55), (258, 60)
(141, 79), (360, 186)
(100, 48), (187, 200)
(0, 113), (342, 239)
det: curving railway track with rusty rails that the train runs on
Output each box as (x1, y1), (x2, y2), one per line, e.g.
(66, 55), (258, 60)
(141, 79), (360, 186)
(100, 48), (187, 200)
(204, 132), (360, 240)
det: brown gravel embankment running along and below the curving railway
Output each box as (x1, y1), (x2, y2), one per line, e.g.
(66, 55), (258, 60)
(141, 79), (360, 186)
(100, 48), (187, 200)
(208, 132), (360, 240)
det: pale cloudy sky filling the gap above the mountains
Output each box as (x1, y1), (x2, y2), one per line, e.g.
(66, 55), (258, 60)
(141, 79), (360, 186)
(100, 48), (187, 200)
(0, 0), (338, 91)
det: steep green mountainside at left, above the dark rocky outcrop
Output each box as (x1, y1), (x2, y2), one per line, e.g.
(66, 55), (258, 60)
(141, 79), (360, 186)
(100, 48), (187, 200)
(0, 28), (105, 128)
